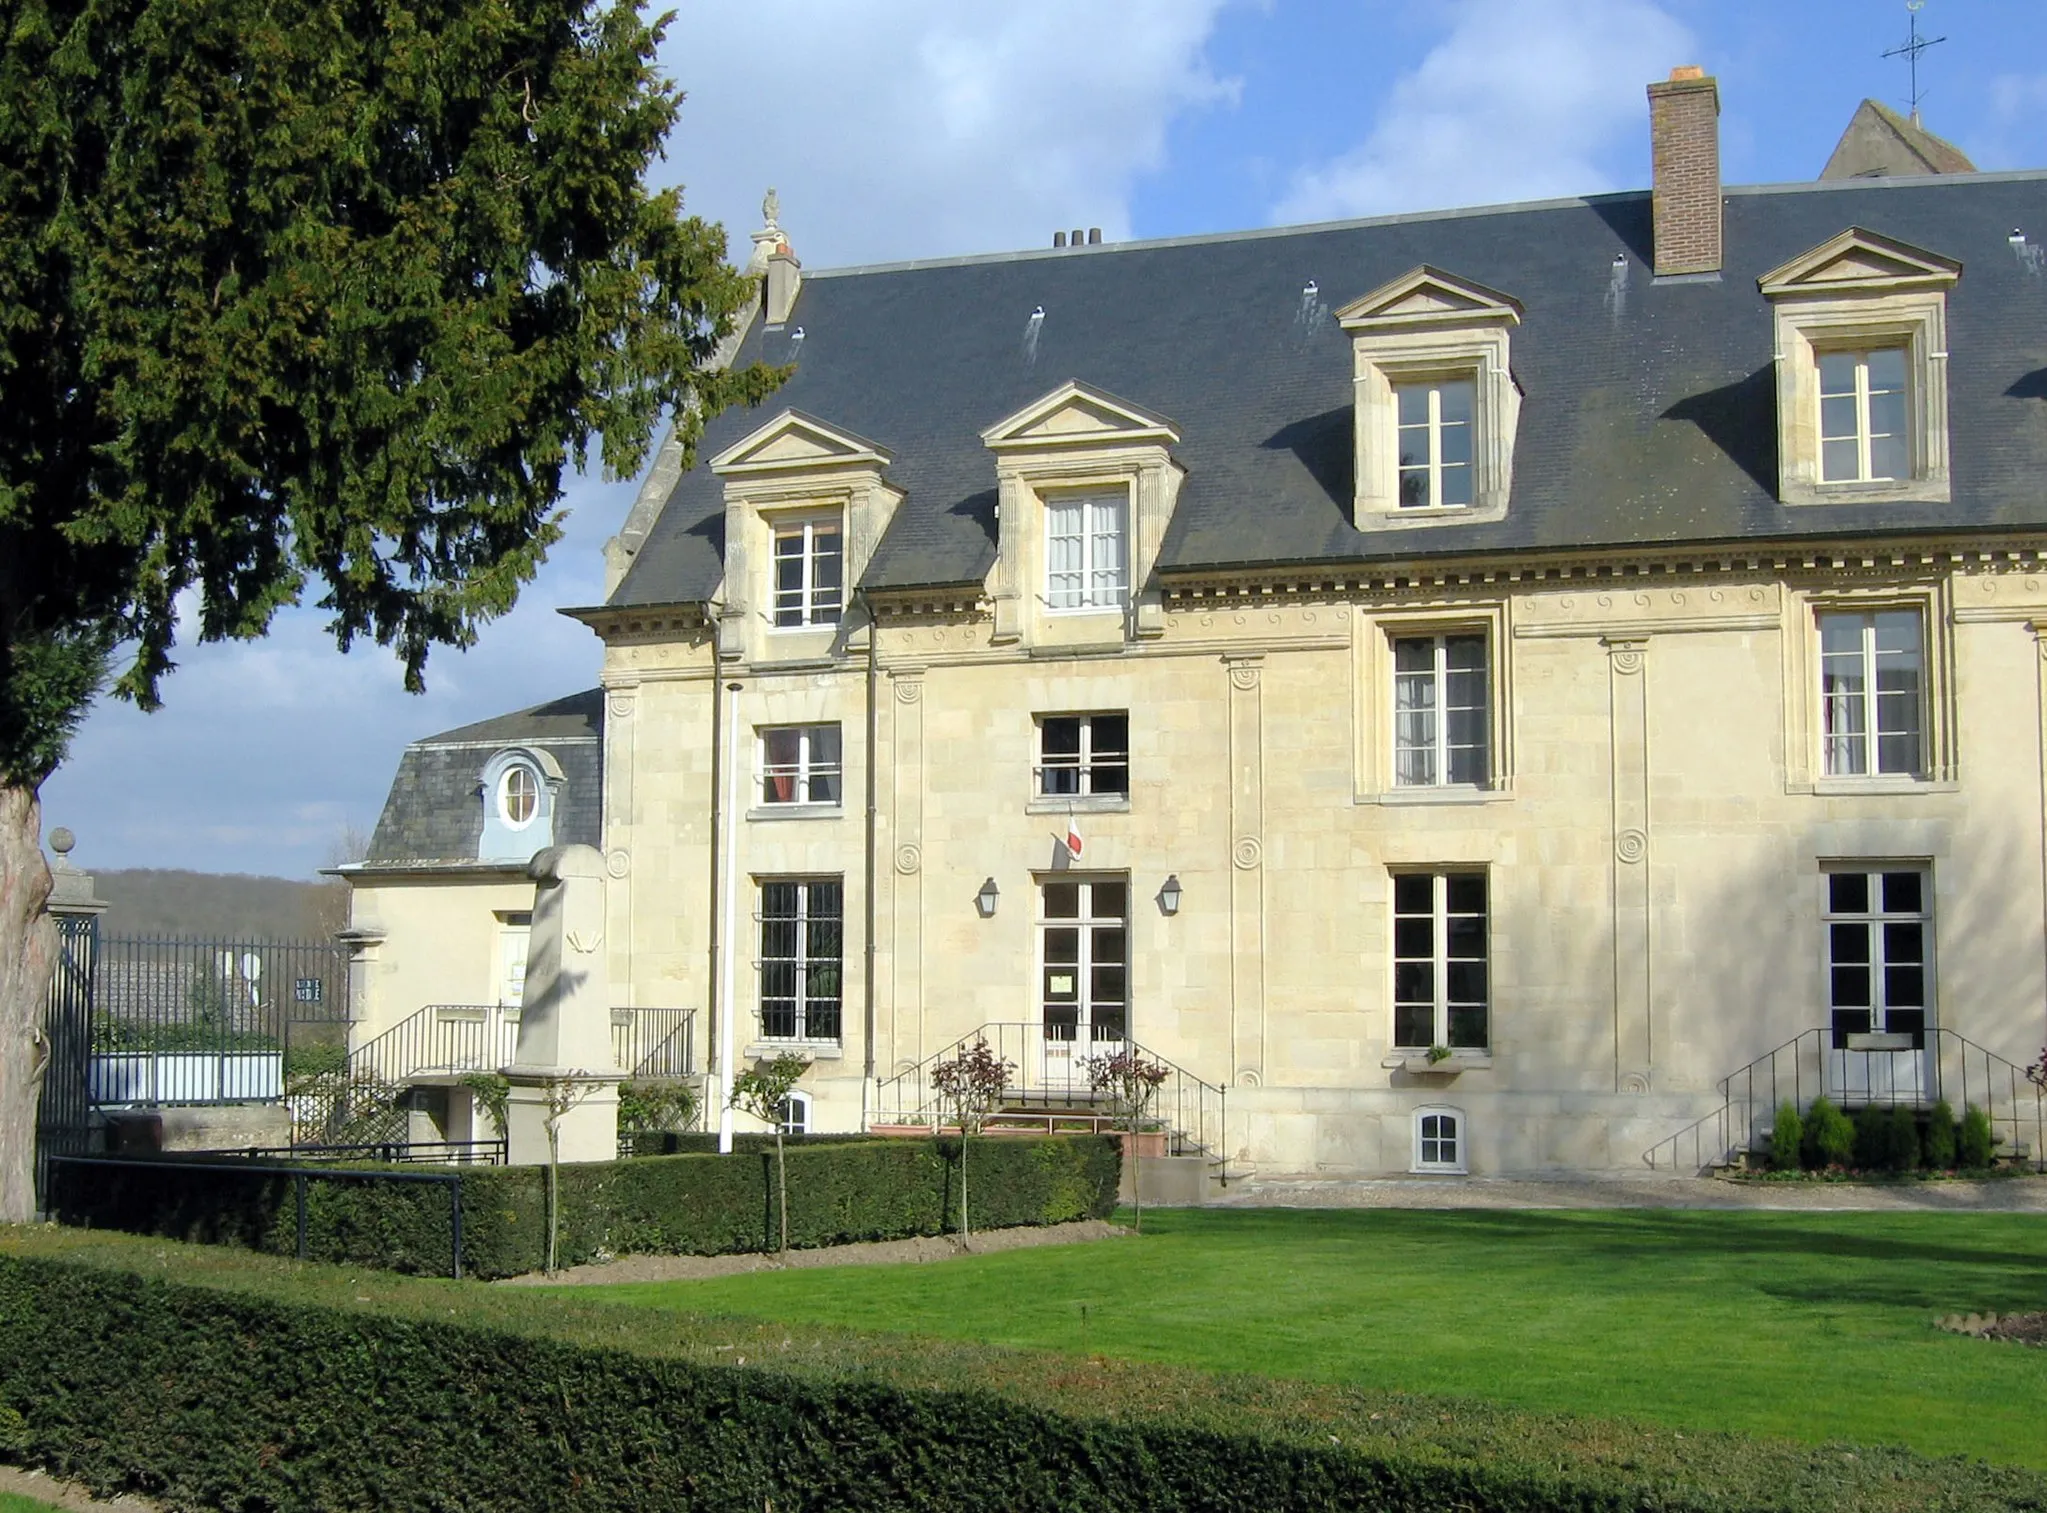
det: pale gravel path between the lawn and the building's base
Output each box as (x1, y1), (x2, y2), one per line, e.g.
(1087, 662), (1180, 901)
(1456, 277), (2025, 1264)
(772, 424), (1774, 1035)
(1210, 1173), (2047, 1214)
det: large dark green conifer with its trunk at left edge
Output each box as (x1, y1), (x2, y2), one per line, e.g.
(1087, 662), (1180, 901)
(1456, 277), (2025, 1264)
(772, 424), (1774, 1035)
(0, 0), (776, 1220)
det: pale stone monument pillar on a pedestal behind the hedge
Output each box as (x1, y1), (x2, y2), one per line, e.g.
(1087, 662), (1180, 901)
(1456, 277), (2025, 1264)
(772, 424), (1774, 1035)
(504, 846), (622, 1165)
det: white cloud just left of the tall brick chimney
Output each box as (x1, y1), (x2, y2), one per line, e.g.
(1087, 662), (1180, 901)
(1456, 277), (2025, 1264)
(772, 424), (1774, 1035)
(1273, 0), (1699, 223)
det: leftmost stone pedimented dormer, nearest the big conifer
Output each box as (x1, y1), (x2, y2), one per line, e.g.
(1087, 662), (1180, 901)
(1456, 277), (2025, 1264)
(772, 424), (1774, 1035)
(710, 409), (903, 661)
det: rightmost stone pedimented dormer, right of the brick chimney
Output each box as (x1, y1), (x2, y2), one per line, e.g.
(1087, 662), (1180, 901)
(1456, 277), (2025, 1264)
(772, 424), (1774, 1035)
(1756, 225), (1961, 504)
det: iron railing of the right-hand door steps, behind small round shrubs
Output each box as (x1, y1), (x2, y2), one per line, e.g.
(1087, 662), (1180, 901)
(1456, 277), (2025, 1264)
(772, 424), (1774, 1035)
(1642, 1028), (2047, 1171)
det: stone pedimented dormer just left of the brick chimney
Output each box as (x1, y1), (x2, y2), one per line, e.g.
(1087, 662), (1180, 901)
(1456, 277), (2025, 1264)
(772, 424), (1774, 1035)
(1337, 264), (1521, 530)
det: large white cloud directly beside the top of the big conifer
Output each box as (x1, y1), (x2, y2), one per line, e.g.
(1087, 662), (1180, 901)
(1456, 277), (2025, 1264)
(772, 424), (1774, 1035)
(661, 0), (1234, 268)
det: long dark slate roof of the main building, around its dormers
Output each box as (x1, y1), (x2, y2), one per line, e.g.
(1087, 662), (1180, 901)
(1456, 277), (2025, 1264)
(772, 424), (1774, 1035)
(610, 172), (2047, 606)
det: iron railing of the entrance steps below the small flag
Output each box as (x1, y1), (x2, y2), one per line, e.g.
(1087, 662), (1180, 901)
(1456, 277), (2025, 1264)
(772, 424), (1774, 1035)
(868, 1024), (1228, 1181)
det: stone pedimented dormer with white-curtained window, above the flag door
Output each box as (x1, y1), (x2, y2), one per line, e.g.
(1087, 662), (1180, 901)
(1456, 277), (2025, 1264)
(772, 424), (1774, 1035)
(981, 379), (1183, 645)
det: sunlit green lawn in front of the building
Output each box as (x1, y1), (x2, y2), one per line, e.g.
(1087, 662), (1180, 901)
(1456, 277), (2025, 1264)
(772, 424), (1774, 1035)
(602, 1210), (2047, 1468)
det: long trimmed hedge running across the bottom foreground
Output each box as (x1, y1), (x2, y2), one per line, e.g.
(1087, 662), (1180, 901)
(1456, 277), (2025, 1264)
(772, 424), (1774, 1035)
(0, 1230), (2047, 1513)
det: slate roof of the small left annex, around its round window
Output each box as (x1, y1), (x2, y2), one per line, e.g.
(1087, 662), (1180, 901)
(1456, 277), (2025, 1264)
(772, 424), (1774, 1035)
(360, 688), (604, 870)
